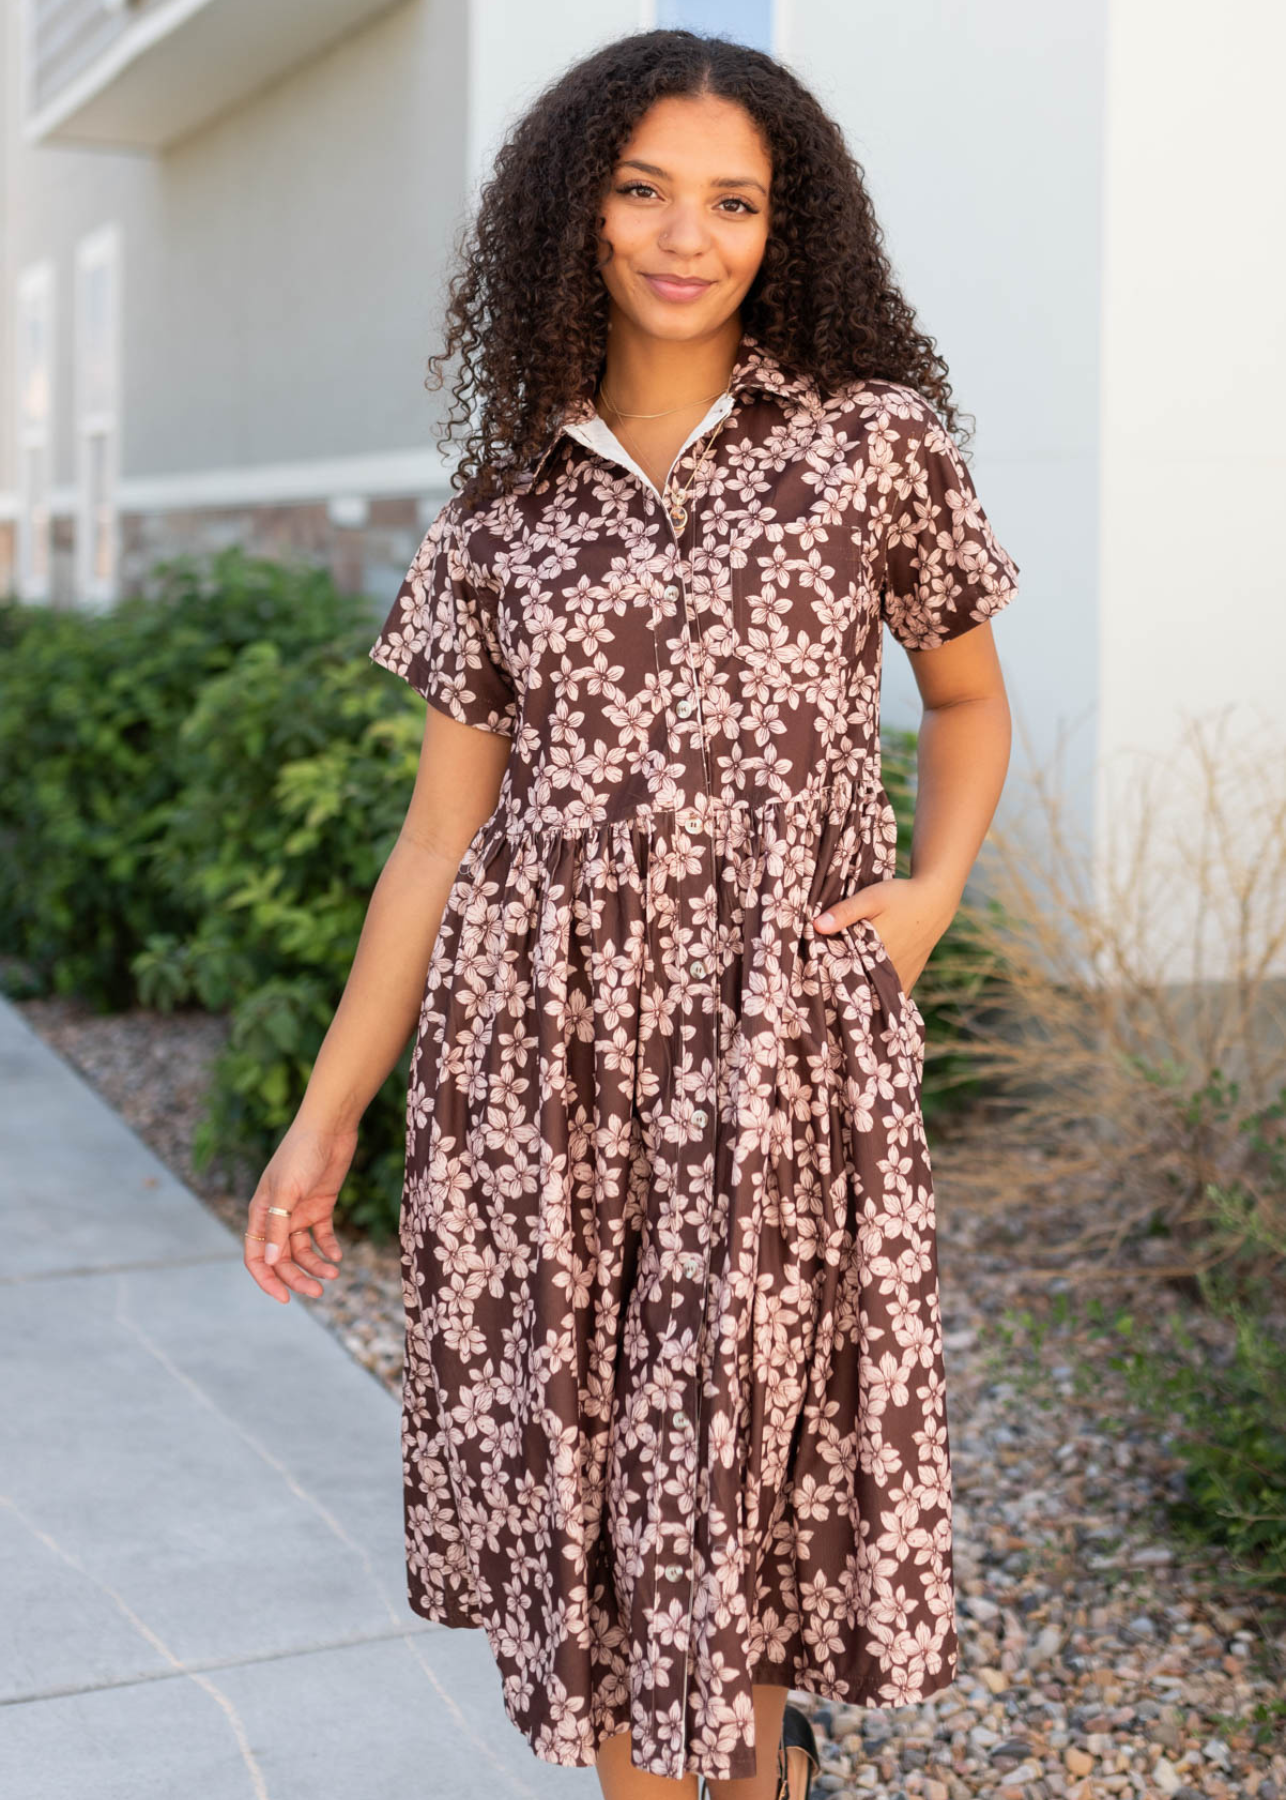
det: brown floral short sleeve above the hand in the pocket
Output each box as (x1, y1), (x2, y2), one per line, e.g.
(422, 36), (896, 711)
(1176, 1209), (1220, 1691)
(872, 387), (1019, 650)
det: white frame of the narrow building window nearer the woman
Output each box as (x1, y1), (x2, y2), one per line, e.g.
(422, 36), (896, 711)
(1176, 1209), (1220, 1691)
(74, 225), (121, 605)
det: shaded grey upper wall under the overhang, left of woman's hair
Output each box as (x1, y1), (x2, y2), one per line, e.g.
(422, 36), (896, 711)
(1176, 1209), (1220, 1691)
(124, 4), (466, 478)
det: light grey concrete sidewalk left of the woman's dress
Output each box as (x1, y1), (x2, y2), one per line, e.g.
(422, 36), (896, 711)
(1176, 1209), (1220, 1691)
(0, 1001), (600, 1800)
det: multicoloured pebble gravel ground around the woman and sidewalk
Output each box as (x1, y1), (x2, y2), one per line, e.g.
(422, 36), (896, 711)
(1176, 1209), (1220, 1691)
(20, 1001), (1286, 1800)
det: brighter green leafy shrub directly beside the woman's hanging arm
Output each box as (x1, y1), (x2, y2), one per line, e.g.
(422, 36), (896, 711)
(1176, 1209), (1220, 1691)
(133, 621), (423, 1238)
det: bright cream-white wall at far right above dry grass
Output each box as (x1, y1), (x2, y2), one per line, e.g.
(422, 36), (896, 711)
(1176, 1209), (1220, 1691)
(1099, 0), (1286, 950)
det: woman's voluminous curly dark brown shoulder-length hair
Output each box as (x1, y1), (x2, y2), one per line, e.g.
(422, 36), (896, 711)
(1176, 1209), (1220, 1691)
(425, 31), (960, 504)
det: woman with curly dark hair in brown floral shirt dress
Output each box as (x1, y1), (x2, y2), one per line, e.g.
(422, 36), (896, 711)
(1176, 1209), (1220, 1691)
(247, 31), (1018, 1800)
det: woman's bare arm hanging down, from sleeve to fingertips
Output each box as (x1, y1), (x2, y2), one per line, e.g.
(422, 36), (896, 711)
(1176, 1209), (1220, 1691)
(245, 706), (513, 1303)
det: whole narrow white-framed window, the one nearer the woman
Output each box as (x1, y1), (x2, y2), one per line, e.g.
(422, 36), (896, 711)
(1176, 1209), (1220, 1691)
(76, 225), (121, 601)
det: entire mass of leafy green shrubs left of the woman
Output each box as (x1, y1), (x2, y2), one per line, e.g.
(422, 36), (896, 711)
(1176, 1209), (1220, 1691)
(0, 549), (423, 1235)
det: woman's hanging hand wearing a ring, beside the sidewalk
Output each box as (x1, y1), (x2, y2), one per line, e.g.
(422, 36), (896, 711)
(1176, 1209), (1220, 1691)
(245, 1120), (357, 1305)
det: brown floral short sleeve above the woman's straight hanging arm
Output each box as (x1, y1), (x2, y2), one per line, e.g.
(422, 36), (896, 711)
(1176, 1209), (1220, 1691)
(369, 497), (519, 736)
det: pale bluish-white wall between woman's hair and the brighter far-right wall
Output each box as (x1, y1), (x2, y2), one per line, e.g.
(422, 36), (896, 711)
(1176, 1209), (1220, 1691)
(782, 0), (1106, 849)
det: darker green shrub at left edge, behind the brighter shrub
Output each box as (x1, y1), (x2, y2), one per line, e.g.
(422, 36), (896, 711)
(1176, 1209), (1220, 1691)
(0, 549), (369, 1012)
